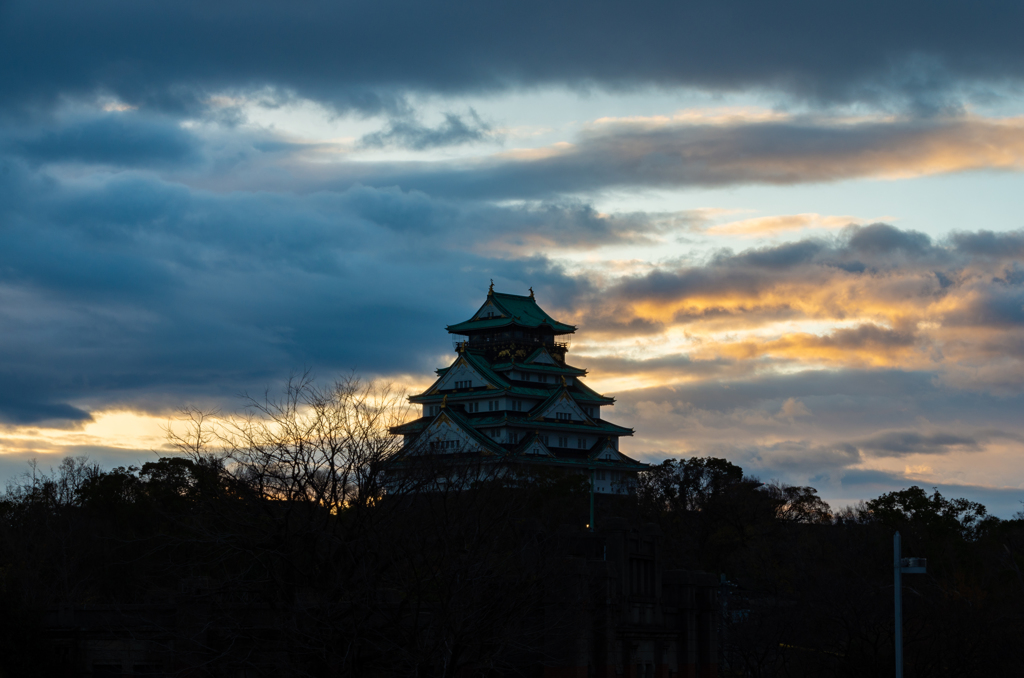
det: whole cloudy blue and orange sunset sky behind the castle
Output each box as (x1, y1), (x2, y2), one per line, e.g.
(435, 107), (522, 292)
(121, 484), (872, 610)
(0, 0), (1024, 517)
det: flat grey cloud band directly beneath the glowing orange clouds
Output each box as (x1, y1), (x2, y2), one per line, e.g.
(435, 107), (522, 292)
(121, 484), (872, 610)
(614, 363), (1024, 444)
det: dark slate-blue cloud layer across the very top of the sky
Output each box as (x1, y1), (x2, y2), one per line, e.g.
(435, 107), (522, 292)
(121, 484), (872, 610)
(0, 0), (1024, 111)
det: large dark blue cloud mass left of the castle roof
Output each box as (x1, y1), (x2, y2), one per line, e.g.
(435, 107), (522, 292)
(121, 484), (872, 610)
(0, 161), (644, 423)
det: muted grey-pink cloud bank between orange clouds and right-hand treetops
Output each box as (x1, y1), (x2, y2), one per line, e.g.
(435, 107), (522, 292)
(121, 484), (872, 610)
(610, 369), (1024, 517)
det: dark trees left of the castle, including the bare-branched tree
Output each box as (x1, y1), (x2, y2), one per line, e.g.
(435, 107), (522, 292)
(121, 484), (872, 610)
(0, 379), (587, 678)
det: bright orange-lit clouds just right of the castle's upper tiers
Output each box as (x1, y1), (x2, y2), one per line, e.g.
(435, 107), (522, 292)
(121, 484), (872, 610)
(581, 224), (1024, 390)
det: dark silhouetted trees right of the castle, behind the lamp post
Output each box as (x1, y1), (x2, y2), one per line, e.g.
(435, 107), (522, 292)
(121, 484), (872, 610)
(637, 458), (1024, 678)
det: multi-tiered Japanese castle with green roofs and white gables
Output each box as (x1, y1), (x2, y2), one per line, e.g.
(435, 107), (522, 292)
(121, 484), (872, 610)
(391, 283), (647, 494)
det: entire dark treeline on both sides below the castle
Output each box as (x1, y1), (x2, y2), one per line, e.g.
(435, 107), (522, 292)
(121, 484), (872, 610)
(0, 379), (1024, 678)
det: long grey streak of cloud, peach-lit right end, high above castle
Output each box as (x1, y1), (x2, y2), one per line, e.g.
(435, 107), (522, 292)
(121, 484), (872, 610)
(209, 116), (1024, 197)
